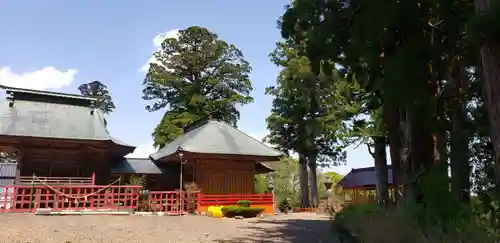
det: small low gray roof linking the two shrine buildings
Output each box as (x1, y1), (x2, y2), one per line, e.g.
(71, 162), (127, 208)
(111, 158), (162, 174)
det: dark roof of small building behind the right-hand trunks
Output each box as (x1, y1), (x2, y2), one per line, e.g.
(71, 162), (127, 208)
(337, 165), (392, 188)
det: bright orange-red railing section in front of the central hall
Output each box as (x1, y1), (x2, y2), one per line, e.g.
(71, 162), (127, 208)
(199, 194), (273, 206)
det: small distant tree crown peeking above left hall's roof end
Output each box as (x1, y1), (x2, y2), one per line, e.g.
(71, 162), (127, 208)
(78, 81), (116, 114)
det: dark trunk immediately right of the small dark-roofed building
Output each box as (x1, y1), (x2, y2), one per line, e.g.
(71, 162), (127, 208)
(382, 100), (404, 206)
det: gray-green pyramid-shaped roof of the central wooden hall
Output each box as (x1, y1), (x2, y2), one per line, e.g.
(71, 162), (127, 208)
(151, 121), (282, 160)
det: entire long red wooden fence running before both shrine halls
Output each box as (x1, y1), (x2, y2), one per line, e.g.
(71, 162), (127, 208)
(0, 185), (273, 213)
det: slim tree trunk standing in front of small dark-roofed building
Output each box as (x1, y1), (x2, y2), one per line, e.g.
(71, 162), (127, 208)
(372, 136), (389, 205)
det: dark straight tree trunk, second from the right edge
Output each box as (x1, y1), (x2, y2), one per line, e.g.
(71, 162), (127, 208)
(450, 58), (471, 203)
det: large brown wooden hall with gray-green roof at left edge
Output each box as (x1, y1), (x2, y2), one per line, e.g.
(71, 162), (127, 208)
(0, 87), (135, 184)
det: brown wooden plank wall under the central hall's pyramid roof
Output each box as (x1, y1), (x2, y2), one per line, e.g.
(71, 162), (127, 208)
(193, 160), (255, 194)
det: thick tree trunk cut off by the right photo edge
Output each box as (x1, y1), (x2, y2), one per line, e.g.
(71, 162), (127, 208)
(474, 0), (500, 185)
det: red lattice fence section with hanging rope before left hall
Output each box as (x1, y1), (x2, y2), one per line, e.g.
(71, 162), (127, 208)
(0, 185), (141, 212)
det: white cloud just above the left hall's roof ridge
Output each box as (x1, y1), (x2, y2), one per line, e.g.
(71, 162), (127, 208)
(0, 67), (77, 90)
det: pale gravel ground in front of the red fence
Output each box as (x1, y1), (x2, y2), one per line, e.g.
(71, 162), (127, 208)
(0, 213), (337, 243)
